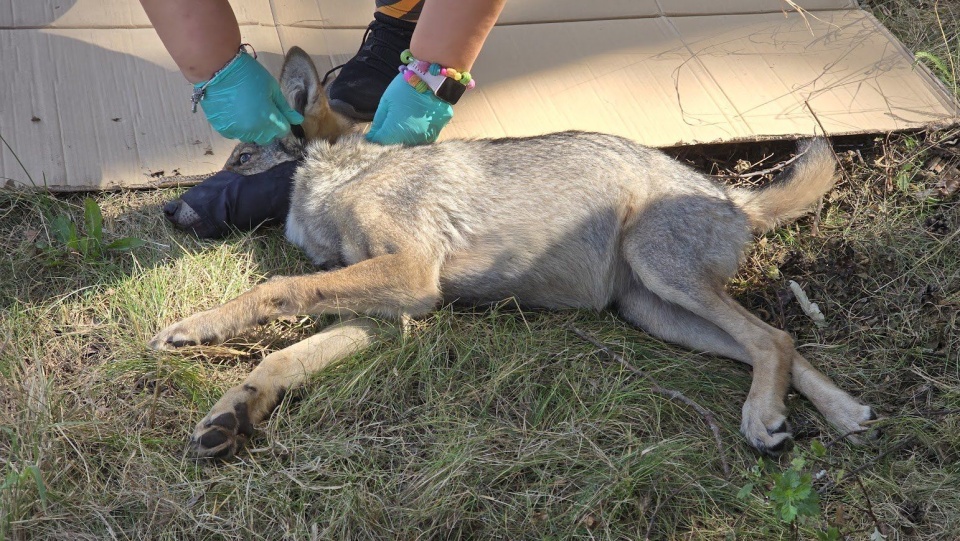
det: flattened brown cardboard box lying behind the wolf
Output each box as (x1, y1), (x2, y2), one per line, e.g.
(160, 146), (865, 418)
(0, 0), (960, 190)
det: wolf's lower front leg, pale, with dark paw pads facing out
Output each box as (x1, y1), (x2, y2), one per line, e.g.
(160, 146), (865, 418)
(188, 318), (395, 458)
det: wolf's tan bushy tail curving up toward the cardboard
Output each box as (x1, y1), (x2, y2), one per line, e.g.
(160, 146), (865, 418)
(730, 137), (837, 232)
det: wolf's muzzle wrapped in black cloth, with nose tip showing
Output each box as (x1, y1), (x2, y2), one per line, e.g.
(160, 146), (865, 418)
(163, 160), (302, 239)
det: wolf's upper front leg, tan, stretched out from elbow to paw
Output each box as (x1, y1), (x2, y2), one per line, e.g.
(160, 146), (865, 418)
(150, 254), (440, 349)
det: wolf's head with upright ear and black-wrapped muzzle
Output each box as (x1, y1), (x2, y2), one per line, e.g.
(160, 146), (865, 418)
(163, 47), (354, 238)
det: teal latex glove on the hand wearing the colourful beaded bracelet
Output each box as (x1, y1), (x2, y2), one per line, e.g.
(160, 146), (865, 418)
(367, 74), (453, 145)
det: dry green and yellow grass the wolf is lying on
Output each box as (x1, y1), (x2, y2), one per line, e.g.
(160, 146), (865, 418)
(0, 0), (960, 540)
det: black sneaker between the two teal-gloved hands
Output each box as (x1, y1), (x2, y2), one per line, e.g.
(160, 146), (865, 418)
(324, 13), (416, 121)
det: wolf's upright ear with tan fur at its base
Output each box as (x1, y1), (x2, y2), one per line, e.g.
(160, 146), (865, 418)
(280, 47), (350, 142)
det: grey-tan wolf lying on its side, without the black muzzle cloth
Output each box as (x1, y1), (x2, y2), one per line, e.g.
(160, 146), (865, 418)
(156, 48), (875, 457)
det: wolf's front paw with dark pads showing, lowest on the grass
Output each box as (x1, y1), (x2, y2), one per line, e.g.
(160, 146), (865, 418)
(187, 390), (253, 458)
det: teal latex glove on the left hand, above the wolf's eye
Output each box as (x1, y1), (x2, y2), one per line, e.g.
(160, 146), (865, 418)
(194, 52), (303, 145)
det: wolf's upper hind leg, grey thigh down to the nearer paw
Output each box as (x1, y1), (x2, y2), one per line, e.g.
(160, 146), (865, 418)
(621, 200), (796, 453)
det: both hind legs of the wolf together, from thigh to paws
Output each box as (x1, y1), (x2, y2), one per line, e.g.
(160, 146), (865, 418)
(622, 196), (873, 453)
